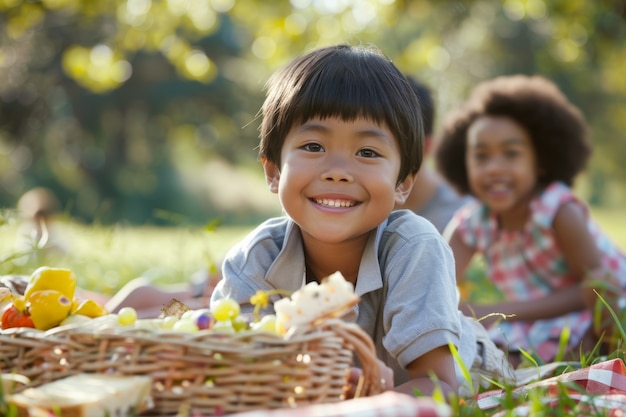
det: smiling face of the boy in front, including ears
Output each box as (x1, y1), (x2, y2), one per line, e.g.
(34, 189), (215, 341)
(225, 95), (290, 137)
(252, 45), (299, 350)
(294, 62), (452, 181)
(263, 117), (414, 243)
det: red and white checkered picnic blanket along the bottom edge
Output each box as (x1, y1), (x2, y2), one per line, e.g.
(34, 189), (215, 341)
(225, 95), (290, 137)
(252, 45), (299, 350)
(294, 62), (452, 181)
(232, 359), (626, 417)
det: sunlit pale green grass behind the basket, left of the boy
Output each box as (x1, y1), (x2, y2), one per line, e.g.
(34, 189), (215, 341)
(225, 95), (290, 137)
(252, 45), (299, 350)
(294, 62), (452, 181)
(0, 218), (251, 295)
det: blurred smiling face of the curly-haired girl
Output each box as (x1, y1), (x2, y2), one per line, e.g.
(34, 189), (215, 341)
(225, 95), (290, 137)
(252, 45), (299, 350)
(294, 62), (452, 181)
(465, 116), (538, 227)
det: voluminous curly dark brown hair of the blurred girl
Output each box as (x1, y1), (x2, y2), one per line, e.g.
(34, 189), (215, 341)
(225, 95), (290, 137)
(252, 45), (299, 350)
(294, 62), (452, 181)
(435, 75), (592, 193)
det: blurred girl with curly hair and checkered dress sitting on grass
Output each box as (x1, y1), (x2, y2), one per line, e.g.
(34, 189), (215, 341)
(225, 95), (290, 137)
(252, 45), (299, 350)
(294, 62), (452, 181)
(436, 75), (626, 363)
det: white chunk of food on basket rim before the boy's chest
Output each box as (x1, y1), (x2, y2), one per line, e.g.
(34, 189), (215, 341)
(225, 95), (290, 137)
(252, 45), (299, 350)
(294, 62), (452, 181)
(274, 271), (360, 332)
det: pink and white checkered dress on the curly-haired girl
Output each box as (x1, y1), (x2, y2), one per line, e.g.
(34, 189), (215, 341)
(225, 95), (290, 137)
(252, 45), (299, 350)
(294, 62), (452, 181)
(453, 182), (626, 361)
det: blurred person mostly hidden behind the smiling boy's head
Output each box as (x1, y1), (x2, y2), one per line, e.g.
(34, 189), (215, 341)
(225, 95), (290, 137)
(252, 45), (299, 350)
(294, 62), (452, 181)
(396, 77), (472, 232)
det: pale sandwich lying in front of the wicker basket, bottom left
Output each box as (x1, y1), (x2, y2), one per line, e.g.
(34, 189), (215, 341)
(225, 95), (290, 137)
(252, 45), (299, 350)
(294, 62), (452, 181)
(7, 374), (152, 417)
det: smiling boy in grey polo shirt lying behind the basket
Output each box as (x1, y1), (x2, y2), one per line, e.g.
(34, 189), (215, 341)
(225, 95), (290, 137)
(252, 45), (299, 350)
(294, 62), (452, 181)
(211, 45), (508, 395)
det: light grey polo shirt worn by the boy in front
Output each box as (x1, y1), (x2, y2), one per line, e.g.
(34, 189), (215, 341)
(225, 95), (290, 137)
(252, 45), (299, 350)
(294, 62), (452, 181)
(212, 210), (476, 385)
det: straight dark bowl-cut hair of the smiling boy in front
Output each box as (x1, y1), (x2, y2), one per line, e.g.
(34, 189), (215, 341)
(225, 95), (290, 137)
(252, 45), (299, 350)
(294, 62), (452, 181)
(259, 45), (424, 183)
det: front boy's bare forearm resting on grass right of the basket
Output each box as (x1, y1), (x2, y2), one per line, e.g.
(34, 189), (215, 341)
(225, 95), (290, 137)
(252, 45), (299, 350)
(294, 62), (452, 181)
(395, 346), (458, 398)
